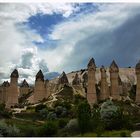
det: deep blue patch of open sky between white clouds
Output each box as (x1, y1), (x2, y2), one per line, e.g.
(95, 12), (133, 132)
(23, 3), (98, 49)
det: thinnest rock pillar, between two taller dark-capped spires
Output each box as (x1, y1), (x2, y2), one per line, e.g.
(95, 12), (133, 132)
(99, 66), (109, 100)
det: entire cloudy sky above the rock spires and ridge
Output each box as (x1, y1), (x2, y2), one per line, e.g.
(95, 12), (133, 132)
(0, 3), (140, 83)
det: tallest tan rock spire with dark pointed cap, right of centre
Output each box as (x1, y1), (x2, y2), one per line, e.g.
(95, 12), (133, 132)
(87, 58), (97, 107)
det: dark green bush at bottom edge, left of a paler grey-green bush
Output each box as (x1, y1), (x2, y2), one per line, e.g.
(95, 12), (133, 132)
(40, 121), (58, 137)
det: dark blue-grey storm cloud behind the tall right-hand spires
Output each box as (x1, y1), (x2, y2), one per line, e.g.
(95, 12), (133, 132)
(65, 11), (140, 69)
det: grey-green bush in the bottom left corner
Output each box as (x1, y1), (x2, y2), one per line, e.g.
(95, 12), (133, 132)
(0, 120), (20, 137)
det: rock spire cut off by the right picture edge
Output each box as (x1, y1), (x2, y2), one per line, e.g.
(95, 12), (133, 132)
(135, 61), (140, 103)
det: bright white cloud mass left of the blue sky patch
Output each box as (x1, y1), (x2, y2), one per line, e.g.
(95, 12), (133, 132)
(0, 3), (79, 81)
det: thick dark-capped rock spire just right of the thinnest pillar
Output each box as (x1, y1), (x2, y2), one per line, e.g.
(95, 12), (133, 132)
(109, 60), (120, 100)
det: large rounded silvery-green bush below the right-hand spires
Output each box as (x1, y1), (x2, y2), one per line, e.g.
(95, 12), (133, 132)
(100, 100), (131, 130)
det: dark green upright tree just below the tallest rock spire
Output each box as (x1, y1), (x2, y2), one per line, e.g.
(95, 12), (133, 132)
(77, 102), (91, 134)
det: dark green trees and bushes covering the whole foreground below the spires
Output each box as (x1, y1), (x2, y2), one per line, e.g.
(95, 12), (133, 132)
(0, 83), (140, 137)
